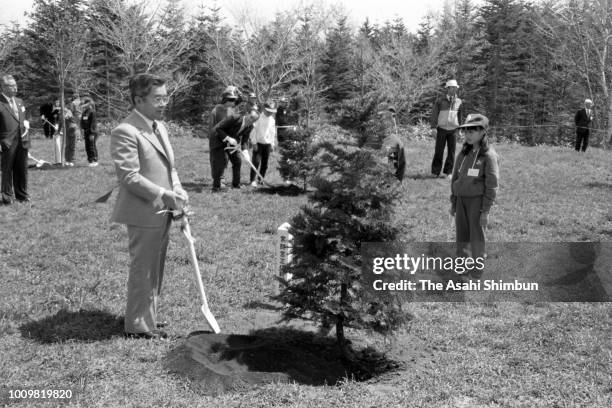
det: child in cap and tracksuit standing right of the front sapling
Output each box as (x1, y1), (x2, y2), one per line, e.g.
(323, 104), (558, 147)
(450, 114), (499, 279)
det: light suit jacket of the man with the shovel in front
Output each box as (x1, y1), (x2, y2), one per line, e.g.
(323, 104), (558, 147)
(110, 112), (181, 227)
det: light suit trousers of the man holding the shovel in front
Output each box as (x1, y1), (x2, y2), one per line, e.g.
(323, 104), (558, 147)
(124, 217), (171, 333)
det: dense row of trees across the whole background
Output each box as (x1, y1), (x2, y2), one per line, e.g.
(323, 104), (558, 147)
(0, 0), (612, 144)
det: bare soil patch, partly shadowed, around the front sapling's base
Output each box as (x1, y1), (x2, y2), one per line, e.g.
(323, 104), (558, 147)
(164, 328), (401, 395)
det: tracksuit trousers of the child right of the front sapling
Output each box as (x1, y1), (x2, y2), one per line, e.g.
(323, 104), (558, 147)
(455, 196), (485, 279)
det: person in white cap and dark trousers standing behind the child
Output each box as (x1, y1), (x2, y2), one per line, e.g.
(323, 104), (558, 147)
(429, 79), (465, 178)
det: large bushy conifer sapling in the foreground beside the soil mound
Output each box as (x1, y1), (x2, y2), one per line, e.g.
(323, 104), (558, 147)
(277, 142), (405, 361)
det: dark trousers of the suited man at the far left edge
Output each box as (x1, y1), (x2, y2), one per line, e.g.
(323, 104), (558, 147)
(0, 137), (29, 204)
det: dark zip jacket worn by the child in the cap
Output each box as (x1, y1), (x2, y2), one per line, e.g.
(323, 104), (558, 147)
(451, 147), (499, 212)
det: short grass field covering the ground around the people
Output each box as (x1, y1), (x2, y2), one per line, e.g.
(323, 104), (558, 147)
(0, 126), (612, 408)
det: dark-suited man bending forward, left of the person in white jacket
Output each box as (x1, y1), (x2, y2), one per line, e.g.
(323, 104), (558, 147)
(210, 109), (259, 191)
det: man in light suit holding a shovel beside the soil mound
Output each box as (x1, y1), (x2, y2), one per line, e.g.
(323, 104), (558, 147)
(111, 74), (188, 338)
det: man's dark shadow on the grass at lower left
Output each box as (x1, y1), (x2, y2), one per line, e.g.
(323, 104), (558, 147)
(19, 309), (123, 344)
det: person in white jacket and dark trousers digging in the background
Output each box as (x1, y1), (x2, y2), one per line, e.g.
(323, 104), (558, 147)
(250, 101), (277, 187)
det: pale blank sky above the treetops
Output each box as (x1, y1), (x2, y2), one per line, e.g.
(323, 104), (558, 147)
(0, 0), (445, 32)
